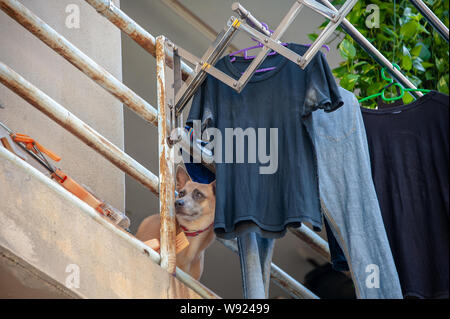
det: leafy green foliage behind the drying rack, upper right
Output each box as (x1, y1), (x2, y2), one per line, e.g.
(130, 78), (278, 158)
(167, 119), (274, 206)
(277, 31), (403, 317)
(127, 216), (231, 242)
(309, 0), (449, 108)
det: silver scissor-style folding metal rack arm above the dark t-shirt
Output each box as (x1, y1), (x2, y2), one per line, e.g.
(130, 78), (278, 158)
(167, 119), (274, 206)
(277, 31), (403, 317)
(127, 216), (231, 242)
(161, 0), (357, 122)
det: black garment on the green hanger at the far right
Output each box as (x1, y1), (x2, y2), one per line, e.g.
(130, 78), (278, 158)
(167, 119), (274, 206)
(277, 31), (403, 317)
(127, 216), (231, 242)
(362, 92), (449, 298)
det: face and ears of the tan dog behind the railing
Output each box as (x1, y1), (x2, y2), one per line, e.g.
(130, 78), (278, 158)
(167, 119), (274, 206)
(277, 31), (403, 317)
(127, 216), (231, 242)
(175, 166), (216, 229)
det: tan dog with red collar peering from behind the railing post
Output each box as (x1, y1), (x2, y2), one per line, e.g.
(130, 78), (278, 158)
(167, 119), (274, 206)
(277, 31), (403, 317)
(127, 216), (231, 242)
(136, 166), (216, 280)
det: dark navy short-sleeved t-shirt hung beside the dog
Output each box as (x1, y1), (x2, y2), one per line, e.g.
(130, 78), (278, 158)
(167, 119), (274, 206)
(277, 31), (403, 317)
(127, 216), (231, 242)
(187, 44), (342, 238)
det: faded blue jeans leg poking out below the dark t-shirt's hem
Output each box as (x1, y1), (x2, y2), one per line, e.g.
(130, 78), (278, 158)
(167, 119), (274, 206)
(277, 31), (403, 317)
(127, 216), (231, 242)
(237, 232), (275, 299)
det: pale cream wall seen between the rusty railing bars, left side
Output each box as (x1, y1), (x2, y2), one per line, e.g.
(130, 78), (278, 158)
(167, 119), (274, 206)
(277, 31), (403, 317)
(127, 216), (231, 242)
(0, 0), (125, 210)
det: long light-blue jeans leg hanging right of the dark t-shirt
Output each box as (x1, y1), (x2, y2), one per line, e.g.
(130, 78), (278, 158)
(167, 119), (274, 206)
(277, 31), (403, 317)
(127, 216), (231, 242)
(305, 88), (403, 299)
